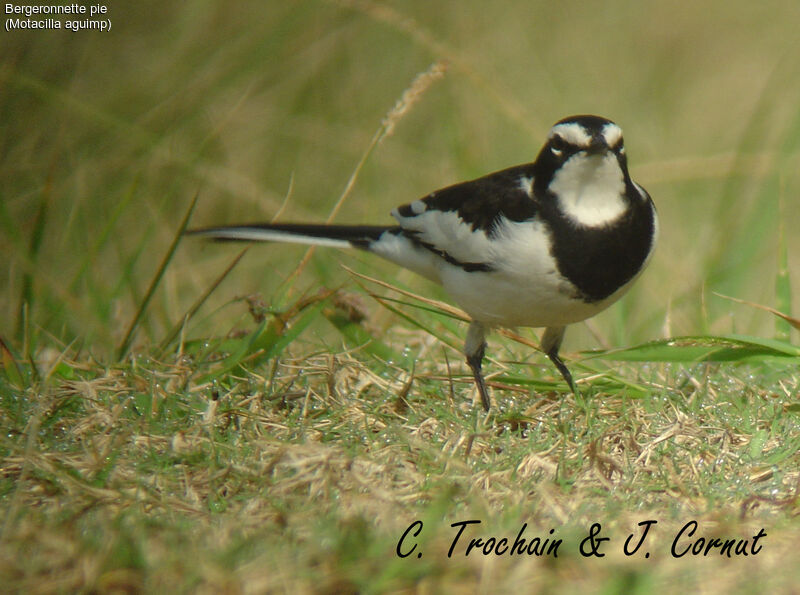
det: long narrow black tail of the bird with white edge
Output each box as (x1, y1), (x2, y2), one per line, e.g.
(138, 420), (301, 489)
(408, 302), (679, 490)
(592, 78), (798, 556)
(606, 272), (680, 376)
(186, 223), (398, 250)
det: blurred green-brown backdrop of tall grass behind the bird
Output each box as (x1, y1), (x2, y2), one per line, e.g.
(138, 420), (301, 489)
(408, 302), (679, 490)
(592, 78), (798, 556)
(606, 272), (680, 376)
(0, 0), (800, 354)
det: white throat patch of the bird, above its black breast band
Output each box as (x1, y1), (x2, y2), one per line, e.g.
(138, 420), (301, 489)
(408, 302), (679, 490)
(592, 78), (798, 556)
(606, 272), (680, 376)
(550, 152), (627, 227)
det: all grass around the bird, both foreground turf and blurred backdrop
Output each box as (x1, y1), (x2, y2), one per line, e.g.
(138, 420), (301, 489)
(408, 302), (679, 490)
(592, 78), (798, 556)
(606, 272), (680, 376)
(0, 0), (800, 593)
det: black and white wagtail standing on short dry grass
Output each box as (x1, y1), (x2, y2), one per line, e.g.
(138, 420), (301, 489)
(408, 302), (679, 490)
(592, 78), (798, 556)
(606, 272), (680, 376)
(189, 115), (658, 411)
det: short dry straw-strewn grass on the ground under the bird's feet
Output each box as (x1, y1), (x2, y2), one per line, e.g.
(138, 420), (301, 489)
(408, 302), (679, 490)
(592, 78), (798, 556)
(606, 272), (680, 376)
(0, 332), (800, 593)
